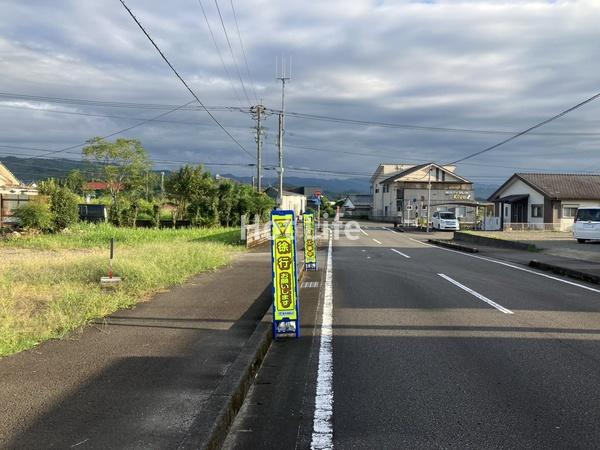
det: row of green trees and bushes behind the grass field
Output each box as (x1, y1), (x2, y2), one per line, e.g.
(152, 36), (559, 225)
(15, 137), (275, 231)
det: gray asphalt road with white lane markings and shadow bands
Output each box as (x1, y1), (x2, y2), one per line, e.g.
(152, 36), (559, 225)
(225, 224), (600, 449)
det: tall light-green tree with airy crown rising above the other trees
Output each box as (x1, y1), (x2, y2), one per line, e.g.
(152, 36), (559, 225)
(83, 137), (152, 205)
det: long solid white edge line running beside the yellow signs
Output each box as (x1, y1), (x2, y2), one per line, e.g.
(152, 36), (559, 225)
(310, 232), (333, 450)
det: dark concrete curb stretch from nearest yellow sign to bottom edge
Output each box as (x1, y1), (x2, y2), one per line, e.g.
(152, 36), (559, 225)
(177, 308), (273, 450)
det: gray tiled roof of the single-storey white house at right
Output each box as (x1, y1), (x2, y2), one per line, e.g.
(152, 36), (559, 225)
(489, 173), (600, 201)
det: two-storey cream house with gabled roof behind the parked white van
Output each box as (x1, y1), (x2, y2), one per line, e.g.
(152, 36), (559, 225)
(371, 162), (477, 225)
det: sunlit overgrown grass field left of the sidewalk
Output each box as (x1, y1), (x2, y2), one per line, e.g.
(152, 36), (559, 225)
(0, 224), (243, 356)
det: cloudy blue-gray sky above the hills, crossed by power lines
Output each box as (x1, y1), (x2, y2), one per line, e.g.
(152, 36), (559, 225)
(0, 0), (600, 184)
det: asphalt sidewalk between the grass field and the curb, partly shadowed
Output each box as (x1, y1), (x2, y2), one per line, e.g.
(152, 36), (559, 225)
(0, 245), (271, 449)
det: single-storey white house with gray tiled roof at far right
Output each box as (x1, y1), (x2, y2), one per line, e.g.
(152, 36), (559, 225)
(488, 173), (600, 231)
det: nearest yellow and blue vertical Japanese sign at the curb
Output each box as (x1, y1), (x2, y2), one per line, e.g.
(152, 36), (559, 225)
(271, 210), (300, 339)
